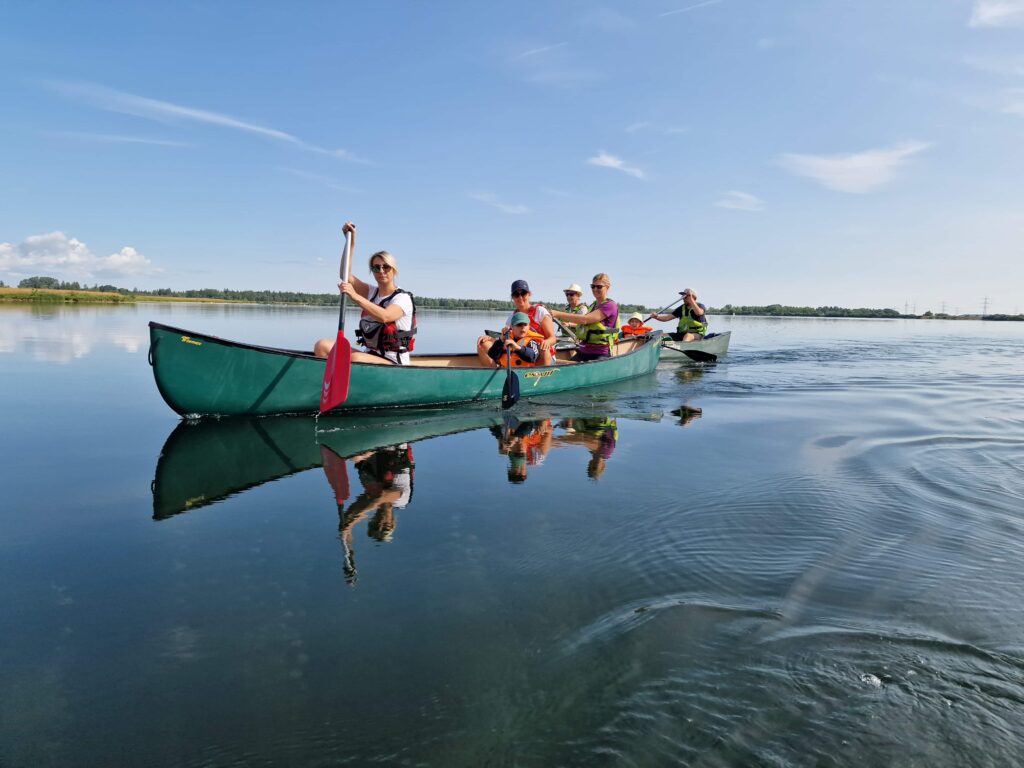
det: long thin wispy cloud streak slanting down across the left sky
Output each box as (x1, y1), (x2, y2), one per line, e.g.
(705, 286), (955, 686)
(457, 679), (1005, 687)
(44, 82), (360, 162)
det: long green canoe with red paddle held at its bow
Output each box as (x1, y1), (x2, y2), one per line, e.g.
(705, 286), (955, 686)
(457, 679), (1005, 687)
(150, 323), (662, 419)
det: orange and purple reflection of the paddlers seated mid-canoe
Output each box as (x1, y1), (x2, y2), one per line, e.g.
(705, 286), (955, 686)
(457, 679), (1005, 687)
(490, 417), (618, 483)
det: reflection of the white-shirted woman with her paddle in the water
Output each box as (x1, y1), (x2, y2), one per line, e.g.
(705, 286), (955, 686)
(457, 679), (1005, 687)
(321, 442), (416, 584)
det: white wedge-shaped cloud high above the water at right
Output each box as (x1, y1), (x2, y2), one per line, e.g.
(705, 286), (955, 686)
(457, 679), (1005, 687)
(779, 141), (931, 195)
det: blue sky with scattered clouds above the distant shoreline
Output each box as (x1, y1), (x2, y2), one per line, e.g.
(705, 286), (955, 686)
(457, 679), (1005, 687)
(0, 0), (1024, 312)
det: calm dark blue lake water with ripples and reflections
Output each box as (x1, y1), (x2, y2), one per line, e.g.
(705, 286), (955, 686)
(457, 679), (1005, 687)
(0, 304), (1024, 768)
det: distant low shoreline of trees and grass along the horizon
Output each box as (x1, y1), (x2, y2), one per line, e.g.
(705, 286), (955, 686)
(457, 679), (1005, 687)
(0, 276), (1024, 321)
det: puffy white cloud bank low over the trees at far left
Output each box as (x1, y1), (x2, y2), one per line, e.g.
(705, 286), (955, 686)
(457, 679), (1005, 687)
(0, 231), (160, 280)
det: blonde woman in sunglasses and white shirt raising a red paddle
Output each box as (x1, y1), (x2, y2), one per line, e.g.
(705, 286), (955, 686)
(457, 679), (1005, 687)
(313, 221), (416, 366)
